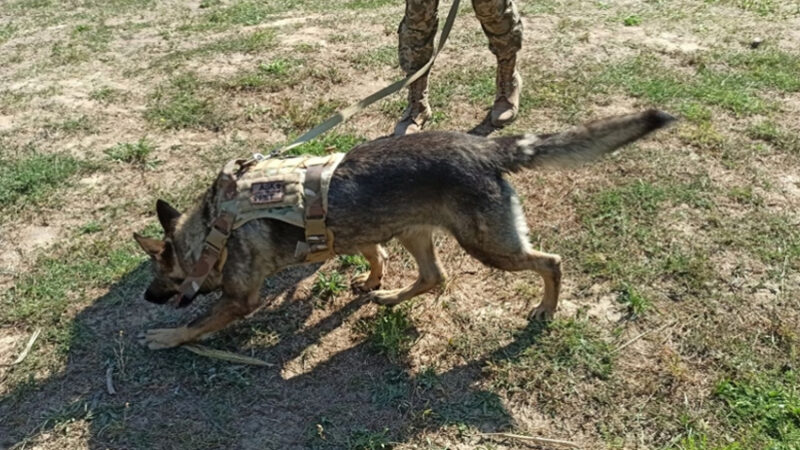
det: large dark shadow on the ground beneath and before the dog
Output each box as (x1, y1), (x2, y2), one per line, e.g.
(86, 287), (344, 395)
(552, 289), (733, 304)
(0, 253), (542, 449)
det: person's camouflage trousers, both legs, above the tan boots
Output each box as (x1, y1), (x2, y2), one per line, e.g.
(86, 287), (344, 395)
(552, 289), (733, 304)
(397, 0), (522, 74)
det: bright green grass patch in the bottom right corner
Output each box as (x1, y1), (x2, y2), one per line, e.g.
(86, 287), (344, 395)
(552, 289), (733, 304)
(715, 370), (800, 450)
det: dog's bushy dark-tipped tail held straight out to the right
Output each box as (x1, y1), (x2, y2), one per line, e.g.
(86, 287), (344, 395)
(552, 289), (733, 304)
(493, 109), (675, 172)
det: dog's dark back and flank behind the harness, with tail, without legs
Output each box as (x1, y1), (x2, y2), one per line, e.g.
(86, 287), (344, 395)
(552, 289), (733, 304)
(328, 110), (674, 253)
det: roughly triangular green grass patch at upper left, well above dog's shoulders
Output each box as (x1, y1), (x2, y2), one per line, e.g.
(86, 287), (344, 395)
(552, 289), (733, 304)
(145, 73), (223, 131)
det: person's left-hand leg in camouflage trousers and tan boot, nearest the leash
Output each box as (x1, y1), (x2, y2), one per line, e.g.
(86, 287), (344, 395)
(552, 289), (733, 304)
(394, 0), (439, 135)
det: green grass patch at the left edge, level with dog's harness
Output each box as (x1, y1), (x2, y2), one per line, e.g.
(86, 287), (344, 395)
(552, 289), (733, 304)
(0, 154), (85, 207)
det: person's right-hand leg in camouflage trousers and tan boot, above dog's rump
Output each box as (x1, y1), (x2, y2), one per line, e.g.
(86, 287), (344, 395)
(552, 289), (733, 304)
(472, 0), (522, 127)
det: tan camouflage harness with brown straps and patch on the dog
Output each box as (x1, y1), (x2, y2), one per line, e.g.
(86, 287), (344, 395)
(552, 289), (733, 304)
(177, 153), (344, 307)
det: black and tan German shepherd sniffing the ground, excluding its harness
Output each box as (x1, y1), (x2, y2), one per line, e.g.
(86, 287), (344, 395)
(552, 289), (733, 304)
(134, 110), (674, 349)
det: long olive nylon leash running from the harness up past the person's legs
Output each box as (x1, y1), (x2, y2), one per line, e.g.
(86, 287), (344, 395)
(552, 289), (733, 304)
(272, 0), (460, 154)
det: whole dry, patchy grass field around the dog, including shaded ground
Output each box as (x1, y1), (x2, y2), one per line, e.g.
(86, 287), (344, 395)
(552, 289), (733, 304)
(0, 0), (800, 450)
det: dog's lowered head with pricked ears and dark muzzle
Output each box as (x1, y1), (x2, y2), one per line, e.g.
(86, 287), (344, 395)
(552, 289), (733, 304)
(133, 200), (224, 306)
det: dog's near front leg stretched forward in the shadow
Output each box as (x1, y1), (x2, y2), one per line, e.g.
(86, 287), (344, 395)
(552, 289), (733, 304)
(142, 289), (259, 350)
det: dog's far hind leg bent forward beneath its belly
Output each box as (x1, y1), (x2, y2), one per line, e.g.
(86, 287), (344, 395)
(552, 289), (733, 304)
(372, 227), (444, 305)
